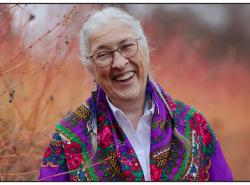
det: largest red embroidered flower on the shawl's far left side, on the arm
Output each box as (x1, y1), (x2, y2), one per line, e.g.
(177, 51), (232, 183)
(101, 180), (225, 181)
(64, 142), (82, 170)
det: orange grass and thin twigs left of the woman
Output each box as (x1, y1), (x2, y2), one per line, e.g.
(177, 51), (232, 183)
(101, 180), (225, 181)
(0, 5), (92, 181)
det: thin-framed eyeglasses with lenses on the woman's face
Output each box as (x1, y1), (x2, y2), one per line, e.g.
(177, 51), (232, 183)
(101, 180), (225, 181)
(87, 38), (141, 68)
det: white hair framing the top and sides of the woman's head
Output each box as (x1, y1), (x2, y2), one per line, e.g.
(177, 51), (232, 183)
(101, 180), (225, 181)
(80, 7), (149, 72)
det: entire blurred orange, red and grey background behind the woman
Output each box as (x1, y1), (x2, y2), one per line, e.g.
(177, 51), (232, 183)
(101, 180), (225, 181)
(0, 4), (250, 181)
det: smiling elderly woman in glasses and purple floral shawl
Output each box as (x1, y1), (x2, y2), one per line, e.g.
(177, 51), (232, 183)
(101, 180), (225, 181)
(40, 7), (232, 181)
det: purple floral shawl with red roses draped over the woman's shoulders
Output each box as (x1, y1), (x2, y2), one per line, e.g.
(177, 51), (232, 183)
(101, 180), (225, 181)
(39, 80), (232, 181)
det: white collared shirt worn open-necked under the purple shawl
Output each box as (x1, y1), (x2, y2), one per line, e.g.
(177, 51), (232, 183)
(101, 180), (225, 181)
(106, 96), (155, 181)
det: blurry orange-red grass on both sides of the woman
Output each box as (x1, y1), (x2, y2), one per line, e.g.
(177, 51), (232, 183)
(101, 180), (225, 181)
(0, 5), (250, 181)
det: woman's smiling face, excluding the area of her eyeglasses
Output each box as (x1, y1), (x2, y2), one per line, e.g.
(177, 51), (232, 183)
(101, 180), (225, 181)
(89, 21), (149, 103)
